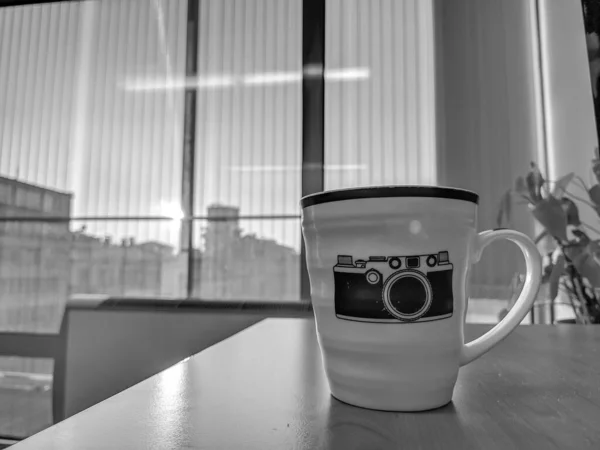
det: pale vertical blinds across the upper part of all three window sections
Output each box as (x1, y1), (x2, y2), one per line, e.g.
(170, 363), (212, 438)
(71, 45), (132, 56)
(0, 0), (436, 215)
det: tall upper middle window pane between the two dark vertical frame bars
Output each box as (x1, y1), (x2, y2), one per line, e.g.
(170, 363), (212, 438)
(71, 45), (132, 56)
(195, 0), (302, 216)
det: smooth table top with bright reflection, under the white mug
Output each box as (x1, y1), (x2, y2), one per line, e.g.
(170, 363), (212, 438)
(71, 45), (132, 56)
(13, 319), (600, 450)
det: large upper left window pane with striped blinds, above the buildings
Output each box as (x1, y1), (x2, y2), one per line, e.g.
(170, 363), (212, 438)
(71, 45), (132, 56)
(0, 0), (187, 216)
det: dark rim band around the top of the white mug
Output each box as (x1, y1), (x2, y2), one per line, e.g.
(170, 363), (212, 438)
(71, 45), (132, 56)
(300, 185), (479, 209)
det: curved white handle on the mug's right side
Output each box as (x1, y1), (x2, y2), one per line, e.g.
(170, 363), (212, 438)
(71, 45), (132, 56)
(460, 229), (542, 366)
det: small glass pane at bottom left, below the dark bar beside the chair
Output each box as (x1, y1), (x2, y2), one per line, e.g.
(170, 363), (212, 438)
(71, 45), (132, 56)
(0, 357), (54, 439)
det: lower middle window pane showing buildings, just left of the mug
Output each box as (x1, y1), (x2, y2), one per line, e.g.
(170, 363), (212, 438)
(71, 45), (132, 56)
(193, 216), (300, 301)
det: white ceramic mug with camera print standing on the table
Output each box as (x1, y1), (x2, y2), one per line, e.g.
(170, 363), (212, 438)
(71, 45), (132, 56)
(301, 186), (542, 411)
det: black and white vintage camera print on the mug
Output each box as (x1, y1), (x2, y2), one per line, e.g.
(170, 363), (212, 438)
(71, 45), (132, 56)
(333, 251), (454, 323)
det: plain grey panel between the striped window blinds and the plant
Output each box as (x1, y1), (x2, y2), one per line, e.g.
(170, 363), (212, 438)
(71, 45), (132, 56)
(434, 0), (544, 298)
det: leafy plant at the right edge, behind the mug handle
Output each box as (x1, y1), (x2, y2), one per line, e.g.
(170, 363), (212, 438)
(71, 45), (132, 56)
(497, 155), (600, 324)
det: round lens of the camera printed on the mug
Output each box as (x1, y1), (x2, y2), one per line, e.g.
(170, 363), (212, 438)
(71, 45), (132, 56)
(383, 270), (433, 322)
